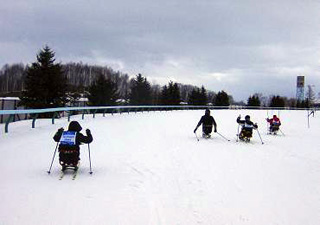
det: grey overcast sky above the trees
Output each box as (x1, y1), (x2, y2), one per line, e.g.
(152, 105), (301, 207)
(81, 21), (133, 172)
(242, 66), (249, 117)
(0, 0), (320, 101)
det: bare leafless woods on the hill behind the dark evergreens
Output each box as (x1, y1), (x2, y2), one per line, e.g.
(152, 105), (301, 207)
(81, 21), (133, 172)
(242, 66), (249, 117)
(0, 63), (220, 102)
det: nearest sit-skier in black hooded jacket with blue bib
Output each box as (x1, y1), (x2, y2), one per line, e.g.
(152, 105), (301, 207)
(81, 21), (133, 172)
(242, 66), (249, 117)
(53, 121), (93, 171)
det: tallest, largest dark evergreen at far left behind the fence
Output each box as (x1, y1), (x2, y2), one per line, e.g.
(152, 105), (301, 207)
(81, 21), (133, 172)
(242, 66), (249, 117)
(20, 46), (67, 108)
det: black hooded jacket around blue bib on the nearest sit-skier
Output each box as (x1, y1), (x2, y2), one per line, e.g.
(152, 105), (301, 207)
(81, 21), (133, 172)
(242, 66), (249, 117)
(53, 121), (93, 150)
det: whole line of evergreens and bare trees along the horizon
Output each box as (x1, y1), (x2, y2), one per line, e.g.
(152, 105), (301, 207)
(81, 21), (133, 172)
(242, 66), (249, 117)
(0, 46), (311, 108)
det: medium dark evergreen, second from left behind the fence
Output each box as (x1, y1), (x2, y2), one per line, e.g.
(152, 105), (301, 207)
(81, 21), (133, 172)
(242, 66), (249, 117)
(88, 74), (117, 106)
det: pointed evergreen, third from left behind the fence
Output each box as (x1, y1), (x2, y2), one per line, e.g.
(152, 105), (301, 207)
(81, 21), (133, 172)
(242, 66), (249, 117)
(130, 74), (152, 105)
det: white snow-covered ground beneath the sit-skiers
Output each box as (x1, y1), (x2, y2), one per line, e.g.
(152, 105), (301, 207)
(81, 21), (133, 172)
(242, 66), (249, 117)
(0, 110), (320, 225)
